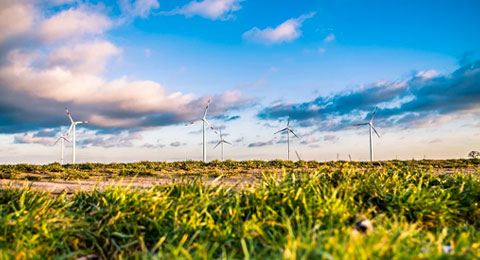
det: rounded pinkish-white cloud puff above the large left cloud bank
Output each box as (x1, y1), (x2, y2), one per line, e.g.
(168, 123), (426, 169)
(40, 8), (113, 42)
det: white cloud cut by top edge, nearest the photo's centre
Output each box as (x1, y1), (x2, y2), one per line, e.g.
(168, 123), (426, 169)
(164, 0), (242, 20)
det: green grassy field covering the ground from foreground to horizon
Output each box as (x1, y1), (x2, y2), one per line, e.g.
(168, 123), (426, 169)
(0, 160), (480, 259)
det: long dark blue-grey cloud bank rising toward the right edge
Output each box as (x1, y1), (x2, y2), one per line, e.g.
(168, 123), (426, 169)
(258, 61), (480, 131)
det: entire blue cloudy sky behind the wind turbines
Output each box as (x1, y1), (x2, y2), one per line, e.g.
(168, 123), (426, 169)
(0, 0), (480, 163)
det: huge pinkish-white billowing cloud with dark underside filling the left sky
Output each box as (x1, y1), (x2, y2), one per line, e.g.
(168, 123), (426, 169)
(0, 2), (256, 133)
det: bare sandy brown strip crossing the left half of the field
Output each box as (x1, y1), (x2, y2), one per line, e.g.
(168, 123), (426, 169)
(0, 176), (257, 194)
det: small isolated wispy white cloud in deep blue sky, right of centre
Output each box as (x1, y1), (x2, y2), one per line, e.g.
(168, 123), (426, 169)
(243, 12), (315, 45)
